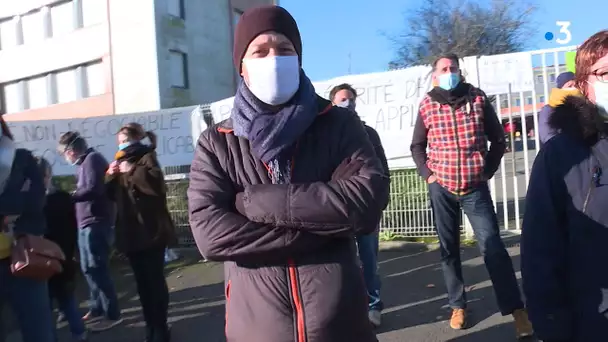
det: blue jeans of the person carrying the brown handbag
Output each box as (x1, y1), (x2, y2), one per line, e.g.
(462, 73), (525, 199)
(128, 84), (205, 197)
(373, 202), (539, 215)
(0, 259), (56, 342)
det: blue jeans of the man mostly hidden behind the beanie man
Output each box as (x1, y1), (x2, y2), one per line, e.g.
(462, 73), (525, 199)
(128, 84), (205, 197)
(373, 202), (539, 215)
(357, 231), (384, 311)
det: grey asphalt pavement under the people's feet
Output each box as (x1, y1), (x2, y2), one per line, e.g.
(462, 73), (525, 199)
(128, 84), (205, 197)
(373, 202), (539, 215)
(4, 235), (536, 342)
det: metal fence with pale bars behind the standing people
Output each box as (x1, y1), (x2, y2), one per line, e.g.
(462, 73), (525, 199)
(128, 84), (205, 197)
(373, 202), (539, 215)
(167, 46), (576, 244)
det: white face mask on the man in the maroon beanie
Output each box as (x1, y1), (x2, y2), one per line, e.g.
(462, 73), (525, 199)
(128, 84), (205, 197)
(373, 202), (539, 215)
(243, 56), (300, 106)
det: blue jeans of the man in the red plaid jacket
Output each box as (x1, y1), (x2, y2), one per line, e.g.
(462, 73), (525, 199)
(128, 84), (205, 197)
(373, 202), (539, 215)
(429, 182), (524, 315)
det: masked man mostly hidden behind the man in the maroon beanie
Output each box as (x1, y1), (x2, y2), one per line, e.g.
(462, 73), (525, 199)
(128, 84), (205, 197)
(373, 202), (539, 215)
(329, 83), (390, 327)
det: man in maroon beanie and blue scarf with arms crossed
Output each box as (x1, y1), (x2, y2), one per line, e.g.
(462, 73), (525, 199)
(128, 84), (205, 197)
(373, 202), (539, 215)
(188, 6), (389, 342)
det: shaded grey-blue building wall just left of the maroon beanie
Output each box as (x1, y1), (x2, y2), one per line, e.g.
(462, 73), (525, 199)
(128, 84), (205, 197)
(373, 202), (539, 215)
(156, 0), (274, 108)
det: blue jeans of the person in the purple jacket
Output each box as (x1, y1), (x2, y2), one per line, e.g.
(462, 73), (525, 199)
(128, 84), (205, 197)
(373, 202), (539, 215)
(78, 224), (120, 320)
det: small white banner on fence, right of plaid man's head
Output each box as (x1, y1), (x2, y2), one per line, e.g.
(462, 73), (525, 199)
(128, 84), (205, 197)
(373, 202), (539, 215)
(477, 52), (534, 95)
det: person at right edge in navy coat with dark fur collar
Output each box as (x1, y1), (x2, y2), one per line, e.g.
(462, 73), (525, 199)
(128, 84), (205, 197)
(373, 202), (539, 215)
(521, 30), (608, 342)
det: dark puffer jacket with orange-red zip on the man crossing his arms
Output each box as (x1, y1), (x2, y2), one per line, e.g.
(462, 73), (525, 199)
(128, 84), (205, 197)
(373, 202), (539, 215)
(188, 98), (389, 342)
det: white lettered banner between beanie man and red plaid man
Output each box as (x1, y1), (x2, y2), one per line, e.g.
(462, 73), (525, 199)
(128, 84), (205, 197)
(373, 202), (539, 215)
(207, 66), (431, 168)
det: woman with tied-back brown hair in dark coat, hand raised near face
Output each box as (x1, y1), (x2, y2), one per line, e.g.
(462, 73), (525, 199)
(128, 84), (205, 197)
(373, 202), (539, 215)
(106, 123), (175, 342)
